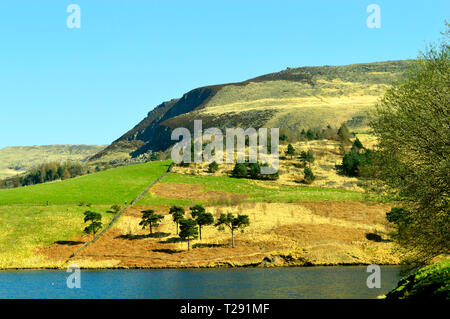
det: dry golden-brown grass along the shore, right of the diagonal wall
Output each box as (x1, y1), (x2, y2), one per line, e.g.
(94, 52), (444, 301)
(41, 202), (398, 268)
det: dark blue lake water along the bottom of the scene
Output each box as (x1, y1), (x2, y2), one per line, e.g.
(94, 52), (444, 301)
(0, 266), (400, 299)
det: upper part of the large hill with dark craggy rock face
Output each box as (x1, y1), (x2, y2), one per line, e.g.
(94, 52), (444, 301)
(92, 61), (409, 161)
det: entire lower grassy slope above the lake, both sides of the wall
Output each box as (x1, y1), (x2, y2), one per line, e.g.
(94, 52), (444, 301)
(0, 161), (398, 269)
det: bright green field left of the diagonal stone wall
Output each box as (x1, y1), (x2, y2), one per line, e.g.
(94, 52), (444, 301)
(0, 161), (169, 269)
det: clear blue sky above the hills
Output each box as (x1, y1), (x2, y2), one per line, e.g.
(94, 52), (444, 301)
(0, 0), (450, 148)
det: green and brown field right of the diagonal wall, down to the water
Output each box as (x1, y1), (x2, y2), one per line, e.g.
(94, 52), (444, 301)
(52, 173), (398, 268)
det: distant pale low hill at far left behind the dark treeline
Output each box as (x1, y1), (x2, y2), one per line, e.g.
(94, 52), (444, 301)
(0, 145), (105, 179)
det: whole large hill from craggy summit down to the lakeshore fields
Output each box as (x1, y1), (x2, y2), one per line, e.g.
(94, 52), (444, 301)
(0, 61), (408, 269)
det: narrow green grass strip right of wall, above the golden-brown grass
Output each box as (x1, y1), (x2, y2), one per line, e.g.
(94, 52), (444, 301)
(138, 173), (375, 205)
